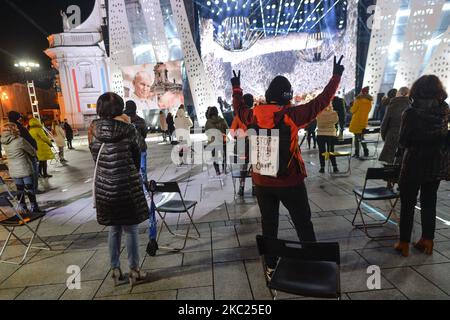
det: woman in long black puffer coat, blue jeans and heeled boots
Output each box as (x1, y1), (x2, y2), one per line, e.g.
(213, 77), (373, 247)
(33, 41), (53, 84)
(89, 92), (149, 283)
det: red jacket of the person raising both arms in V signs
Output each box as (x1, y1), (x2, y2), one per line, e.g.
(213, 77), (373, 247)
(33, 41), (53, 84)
(233, 75), (341, 187)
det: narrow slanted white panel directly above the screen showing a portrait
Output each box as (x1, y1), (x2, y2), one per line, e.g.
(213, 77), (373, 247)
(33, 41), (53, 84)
(140, 0), (169, 62)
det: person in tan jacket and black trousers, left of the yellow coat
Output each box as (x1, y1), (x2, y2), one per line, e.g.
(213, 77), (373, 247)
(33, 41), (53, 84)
(317, 105), (339, 173)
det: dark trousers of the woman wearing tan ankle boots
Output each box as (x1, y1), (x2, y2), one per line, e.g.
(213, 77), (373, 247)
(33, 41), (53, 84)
(400, 181), (440, 242)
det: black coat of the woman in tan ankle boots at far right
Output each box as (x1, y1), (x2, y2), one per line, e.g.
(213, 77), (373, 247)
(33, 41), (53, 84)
(399, 100), (450, 185)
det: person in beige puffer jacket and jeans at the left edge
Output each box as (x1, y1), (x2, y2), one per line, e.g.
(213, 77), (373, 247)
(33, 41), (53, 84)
(1, 122), (43, 214)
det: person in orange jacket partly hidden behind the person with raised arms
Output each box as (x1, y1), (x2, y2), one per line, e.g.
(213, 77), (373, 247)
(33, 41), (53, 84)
(230, 94), (255, 197)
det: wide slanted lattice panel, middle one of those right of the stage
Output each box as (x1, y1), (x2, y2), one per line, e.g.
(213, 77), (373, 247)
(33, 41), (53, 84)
(394, 0), (445, 88)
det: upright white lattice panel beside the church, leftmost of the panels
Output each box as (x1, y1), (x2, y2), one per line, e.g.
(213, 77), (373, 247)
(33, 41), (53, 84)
(109, 0), (134, 96)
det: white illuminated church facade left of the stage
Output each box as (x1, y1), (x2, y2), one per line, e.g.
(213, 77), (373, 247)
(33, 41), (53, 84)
(45, 0), (110, 129)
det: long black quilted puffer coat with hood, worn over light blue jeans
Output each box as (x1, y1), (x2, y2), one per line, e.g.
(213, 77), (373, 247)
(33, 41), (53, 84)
(89, 119), (149, 226)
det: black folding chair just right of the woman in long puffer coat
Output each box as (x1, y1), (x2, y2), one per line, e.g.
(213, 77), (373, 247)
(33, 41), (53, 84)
(149, 181), (200, 251)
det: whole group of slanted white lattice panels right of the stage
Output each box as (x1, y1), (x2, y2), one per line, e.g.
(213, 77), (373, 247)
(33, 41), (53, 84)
(364, 0), (450, 109)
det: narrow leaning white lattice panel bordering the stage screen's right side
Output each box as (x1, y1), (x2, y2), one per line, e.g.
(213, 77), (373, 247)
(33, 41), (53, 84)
(364, 0), (401, 97)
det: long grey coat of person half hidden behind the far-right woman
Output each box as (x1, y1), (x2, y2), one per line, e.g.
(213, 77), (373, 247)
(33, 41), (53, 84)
(379, 97), (411, 163)
